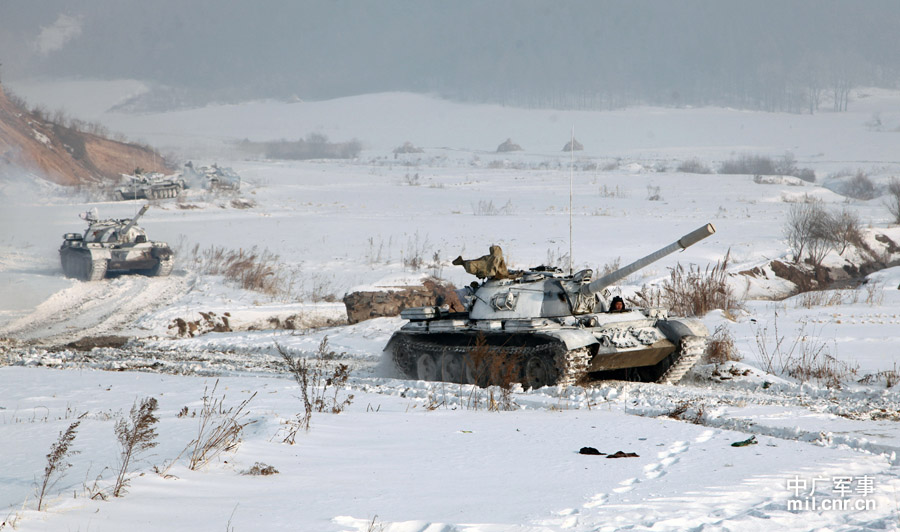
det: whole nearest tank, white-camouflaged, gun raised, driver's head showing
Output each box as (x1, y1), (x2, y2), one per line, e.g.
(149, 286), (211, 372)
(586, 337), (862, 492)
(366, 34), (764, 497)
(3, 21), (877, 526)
(385, 224), (715, 388)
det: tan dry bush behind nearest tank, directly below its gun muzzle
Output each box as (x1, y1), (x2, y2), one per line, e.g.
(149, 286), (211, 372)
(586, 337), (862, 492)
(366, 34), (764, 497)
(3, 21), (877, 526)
(660, 250), (741, 316)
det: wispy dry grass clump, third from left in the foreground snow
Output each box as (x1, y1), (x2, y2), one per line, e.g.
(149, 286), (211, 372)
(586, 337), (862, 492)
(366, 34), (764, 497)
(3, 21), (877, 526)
(186, 380), (256, 471)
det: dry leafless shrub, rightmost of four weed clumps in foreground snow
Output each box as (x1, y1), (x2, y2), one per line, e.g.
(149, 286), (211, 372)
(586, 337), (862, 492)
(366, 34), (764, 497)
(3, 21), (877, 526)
(275, 336), (353, 445)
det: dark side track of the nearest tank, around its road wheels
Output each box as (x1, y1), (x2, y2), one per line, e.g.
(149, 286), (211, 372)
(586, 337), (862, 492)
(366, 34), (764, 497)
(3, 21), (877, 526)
(391, 335), (591, 387)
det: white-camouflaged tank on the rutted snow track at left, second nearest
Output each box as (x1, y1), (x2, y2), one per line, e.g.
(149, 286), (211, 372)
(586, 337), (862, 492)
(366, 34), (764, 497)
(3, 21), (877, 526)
(59, 205), (175, 281)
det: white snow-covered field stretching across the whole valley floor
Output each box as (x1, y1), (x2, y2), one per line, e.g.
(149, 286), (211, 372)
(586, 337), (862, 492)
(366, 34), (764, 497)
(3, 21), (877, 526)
(0, 82), (900, 532)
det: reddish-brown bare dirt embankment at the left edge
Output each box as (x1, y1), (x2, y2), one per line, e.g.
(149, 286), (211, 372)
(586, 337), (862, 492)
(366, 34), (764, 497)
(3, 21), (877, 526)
(0, 86), (172, 185)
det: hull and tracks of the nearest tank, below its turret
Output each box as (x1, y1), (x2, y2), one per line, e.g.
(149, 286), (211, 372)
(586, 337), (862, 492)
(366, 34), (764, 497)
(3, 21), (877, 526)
(385, 312), (706, 388)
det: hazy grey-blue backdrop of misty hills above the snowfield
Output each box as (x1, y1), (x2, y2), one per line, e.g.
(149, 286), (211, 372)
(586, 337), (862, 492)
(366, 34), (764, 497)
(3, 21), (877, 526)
(0, 0), (900, 109)
